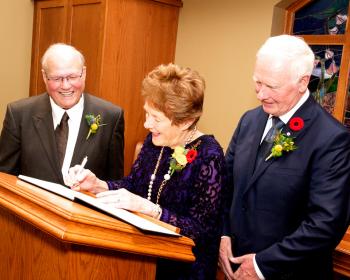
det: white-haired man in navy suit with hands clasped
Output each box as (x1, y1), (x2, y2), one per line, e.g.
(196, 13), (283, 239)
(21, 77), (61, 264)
(220, 35), (350, 280)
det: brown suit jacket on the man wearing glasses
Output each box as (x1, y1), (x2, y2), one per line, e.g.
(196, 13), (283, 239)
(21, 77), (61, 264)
(0, 93), (124, 184)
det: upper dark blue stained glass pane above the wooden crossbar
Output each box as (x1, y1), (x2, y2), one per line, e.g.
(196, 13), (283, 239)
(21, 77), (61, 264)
(293, 0), (349, 35)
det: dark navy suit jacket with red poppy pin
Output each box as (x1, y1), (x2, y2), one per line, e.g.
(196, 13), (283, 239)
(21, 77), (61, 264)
(224, 97), (350, 280)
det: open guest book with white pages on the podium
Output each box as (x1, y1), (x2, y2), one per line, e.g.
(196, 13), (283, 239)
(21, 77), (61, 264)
(18, 175), (181, 236)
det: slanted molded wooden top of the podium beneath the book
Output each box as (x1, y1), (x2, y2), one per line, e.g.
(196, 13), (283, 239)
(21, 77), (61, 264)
(0, 172), (195, 261)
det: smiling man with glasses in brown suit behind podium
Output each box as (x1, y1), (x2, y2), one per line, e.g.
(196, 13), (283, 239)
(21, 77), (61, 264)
(0, 44), (124, 184)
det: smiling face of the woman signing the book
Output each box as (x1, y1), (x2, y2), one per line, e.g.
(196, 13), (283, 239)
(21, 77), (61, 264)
(143, 101), (191, 148)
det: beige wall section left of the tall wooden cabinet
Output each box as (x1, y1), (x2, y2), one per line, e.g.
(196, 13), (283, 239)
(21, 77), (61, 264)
(0, 0), (34, 129)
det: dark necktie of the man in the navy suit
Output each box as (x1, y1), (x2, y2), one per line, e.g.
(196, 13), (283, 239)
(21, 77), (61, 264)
(255, 117), (284, 168)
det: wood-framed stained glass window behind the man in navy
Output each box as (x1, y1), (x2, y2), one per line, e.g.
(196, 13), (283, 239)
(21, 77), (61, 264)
(280, 0), (350, 128)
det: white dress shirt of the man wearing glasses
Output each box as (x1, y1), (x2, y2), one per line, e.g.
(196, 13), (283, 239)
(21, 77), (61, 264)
(50, 94), (84, 178)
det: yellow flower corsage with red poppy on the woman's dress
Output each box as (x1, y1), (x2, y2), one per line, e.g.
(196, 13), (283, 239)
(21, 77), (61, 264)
(169, 141), (201, 176)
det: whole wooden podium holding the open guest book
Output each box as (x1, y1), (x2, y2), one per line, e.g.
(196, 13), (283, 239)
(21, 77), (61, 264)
(0, 172), (194, 280)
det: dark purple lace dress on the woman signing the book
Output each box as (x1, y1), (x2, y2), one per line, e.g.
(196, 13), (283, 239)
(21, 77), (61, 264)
(107, 134), (226, 279)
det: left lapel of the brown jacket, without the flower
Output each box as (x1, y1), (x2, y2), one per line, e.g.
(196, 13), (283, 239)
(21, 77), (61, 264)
(32, 95), (62, 178)
